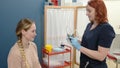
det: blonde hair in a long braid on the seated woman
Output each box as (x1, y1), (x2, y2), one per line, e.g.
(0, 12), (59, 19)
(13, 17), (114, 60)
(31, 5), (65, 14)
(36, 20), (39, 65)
(16, 18), (34, 68)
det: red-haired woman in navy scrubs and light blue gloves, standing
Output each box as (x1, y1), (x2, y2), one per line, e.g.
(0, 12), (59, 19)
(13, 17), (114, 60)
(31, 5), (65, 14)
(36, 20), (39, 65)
(70, 0), (115, 68)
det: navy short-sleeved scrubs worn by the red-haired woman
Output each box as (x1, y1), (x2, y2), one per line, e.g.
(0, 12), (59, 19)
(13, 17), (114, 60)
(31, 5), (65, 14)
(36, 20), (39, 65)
(80, 22), (115, 68)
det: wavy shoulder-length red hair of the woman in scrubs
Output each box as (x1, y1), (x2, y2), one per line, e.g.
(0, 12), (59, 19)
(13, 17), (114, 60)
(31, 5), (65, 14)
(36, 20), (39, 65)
(88, 0), (108, 24)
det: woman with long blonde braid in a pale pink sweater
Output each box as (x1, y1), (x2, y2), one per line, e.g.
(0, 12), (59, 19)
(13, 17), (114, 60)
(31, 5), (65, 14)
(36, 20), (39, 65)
(7, 18), (41, 68)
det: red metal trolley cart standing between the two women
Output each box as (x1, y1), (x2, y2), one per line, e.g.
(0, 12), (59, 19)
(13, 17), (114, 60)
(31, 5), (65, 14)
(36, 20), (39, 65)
(42, 45), (72, 68)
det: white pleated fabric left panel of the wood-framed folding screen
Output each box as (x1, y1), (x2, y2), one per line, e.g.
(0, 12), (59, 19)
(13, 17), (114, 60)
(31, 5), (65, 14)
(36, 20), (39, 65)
(45, 6), (74, 47)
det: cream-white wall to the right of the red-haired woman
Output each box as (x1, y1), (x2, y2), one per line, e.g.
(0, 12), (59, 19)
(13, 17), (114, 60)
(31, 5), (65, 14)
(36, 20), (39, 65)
(105, 0), (120, 34)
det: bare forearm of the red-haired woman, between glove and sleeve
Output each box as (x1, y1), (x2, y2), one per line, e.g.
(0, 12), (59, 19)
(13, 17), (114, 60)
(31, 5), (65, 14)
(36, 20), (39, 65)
(80, 47), (109, 61)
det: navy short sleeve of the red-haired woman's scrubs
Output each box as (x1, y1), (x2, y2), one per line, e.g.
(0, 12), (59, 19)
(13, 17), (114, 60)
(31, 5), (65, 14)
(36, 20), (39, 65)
(98, 24), (115, 48)
